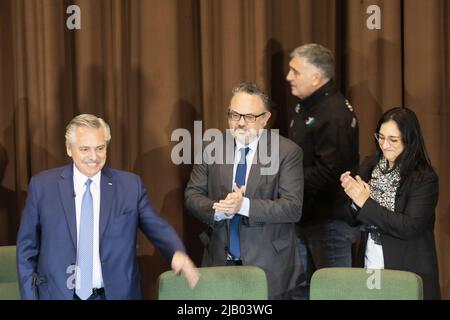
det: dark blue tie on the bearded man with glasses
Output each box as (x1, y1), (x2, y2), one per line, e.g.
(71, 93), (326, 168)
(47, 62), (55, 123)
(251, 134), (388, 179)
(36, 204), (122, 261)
(230, 147), (250, 259)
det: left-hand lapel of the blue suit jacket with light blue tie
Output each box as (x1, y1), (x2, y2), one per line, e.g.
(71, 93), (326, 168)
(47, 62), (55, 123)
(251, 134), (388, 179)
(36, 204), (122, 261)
(59, 164), (77, 248)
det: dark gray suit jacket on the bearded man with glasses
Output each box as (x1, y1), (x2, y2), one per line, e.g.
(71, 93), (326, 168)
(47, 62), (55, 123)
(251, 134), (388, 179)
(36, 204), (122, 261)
(185, 131), (303, 296)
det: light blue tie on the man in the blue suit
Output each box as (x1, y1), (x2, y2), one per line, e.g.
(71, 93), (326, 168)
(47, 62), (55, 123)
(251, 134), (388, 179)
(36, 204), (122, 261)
(76, 179), (94, 300)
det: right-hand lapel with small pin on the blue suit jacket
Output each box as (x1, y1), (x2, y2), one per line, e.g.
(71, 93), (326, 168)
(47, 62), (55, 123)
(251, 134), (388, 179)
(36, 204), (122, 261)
(99, 166), (114, 240)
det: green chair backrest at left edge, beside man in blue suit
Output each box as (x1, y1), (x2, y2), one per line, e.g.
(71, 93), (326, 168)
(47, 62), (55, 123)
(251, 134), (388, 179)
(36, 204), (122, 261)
(0, 246), (20, 300)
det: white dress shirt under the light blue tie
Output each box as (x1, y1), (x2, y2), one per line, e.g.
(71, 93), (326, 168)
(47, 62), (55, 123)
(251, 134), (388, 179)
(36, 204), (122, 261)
(73, 164), (103, 288)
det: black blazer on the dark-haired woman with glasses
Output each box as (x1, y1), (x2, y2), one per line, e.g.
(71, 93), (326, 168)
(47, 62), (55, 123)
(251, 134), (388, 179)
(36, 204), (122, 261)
(350, 157), (440, 299)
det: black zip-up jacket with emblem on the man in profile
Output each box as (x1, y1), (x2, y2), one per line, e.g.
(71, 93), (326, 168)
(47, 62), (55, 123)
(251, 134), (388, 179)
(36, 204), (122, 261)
(289, 80), (359, 224)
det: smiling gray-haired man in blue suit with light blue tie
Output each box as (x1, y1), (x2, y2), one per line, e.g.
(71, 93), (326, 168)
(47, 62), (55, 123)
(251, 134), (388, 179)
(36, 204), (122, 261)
(17, 114), (198, 300)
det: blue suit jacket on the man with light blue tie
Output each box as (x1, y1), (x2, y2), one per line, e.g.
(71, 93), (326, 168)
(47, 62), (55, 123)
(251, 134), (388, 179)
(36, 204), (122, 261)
(17, 164), (185, 300)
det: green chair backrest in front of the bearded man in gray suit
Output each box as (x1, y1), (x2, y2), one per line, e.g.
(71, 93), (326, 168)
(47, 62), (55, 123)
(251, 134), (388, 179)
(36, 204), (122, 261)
(157, 266), (267, 300)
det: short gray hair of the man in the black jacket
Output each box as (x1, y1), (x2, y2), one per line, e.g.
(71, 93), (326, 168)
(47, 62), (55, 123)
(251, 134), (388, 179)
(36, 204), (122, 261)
(291, 43), (334, 79)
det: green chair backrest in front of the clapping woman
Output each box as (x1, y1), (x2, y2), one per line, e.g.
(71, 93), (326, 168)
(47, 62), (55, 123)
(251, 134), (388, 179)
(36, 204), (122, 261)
(310, 268), (423, 300)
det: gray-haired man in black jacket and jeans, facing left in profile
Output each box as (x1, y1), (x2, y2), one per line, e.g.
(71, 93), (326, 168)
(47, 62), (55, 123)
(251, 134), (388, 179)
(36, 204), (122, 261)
(287, 44), (359, 298)
